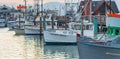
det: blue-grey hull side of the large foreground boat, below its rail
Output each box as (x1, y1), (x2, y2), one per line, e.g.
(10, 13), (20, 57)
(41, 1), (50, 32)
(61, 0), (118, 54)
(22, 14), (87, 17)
(79, 43), (120, 59)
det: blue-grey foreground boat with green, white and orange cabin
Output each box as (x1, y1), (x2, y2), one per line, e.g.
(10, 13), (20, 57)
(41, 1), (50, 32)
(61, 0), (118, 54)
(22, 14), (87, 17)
(77, 14), (120, 59)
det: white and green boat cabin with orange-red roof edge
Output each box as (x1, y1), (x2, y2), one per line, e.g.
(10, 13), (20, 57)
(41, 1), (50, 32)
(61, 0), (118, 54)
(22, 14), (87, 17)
(106, 14), (120, 36)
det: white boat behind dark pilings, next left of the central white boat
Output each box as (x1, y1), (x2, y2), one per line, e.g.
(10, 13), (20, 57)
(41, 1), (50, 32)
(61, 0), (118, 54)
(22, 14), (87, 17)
(25, 16), (57, 35)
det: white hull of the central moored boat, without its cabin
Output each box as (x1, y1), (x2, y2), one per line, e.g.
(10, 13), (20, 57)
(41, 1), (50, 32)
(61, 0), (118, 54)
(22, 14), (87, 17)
(43, 31), (77, 43)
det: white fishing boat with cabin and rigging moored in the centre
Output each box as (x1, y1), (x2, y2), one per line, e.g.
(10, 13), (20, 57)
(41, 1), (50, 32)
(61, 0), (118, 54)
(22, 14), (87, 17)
(44, 0), (97, 44)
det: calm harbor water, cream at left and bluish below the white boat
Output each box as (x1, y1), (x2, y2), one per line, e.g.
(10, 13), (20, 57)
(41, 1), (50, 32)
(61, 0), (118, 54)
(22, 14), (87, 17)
(0, 28), (79, 59)
